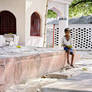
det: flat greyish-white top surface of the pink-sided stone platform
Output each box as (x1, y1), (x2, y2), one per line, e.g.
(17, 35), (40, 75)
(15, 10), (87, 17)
(0, 46), (62, 58)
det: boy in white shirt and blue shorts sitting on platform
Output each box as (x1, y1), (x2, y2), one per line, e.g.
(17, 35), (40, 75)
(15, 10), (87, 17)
(62, 28), (74, 67)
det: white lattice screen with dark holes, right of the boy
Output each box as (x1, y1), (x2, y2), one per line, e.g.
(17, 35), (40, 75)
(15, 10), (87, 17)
(71, 25), (92, 50)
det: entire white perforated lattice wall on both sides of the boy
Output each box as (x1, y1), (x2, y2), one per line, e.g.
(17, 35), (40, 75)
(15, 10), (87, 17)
(47, 24), (92, 50)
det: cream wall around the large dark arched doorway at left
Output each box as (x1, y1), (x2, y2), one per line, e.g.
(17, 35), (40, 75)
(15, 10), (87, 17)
(0, 0), (25, 44)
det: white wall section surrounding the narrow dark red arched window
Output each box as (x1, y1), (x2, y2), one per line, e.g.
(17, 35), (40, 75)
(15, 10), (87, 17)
(25, 0), (47, 47)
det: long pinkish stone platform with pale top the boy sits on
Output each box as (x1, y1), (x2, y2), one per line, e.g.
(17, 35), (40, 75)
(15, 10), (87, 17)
(0, 47), (65, 92)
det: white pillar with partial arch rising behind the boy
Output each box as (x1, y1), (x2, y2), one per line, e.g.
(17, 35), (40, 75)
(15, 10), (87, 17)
(48, 1), (69, 47)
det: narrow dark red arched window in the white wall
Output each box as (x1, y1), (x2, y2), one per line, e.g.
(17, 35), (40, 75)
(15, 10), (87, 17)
(30, 12), (41, 36)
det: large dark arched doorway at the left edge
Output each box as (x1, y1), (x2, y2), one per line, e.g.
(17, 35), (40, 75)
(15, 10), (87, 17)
(0, 11), (16, 35)
